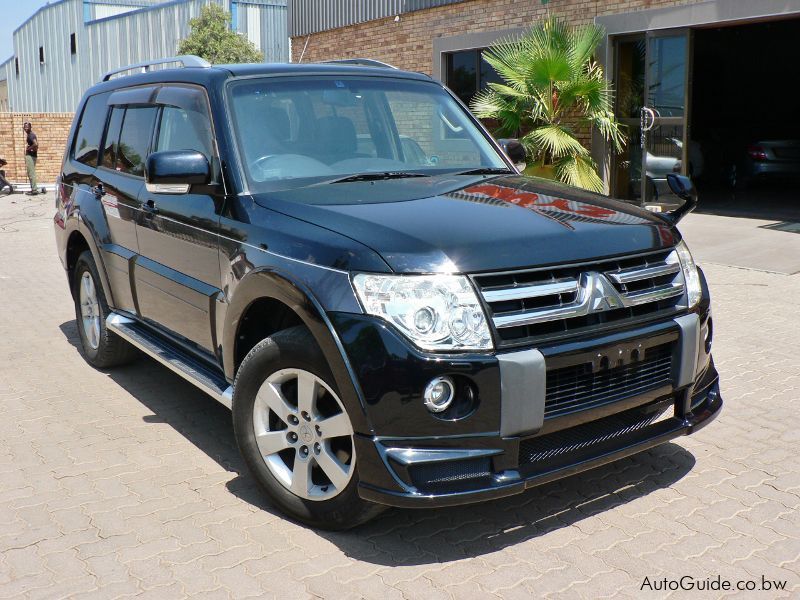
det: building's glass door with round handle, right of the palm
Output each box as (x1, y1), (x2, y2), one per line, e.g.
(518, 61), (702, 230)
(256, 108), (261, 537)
(614, 29), (691, 209)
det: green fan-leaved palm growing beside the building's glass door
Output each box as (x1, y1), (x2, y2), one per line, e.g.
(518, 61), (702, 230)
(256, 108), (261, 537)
(471, 17), (625, 192)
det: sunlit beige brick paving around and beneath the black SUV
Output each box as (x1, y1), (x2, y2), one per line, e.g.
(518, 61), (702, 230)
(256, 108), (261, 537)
(0, 196), (800, 600)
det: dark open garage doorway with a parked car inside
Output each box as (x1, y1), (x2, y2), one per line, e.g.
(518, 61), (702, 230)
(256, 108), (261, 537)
(688, 19), (800, 221)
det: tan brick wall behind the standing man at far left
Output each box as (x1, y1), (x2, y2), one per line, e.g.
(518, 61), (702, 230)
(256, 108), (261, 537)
(0, 113), (73, 185)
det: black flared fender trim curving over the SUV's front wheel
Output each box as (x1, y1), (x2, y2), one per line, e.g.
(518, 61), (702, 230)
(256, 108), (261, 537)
(222, 268), (373, 434)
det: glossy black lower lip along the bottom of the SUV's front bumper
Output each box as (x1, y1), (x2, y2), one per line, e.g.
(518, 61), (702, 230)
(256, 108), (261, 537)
(359, 381), (722, 508)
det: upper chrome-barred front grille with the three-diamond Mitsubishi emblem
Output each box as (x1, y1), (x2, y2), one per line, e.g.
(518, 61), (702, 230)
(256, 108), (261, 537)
(473, 250), (685, 348)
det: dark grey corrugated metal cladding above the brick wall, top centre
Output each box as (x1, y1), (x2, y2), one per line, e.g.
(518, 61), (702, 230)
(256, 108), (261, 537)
(289, 0), (464, 37)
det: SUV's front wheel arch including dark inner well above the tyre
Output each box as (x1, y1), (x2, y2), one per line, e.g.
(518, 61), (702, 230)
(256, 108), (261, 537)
(222, 269), (372, 433)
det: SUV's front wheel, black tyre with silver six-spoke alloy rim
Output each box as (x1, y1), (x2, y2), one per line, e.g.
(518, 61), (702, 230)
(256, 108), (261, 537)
(233, 326), (383, 530)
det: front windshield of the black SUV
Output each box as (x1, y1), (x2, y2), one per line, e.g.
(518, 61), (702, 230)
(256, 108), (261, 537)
(230, 76), (507, 192)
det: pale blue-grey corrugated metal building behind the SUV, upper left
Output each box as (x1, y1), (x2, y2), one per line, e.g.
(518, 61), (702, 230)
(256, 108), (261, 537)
(0, 0), (289, 112)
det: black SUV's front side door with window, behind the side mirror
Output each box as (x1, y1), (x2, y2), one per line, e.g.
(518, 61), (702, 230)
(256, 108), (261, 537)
(135, 84), (224, 354)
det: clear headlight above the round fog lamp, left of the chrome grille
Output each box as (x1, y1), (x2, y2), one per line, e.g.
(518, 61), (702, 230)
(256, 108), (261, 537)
(353, 273), (492, 350)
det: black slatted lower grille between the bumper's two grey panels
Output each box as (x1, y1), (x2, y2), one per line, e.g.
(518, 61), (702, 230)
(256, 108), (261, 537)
(544, 344), (672, 419)
